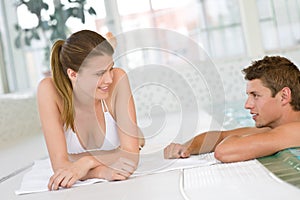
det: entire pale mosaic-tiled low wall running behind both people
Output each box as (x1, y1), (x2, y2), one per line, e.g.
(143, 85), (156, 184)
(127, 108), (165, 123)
(0, 51), (300, 146)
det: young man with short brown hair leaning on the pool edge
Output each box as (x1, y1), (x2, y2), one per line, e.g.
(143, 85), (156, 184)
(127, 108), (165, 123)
(164, 56), (300, 162)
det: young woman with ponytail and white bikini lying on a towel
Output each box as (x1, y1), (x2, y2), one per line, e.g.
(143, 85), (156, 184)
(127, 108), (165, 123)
(37, 30), (140, 190)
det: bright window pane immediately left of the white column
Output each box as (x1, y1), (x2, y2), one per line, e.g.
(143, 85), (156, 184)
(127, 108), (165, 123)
(197, 0), (245, 58)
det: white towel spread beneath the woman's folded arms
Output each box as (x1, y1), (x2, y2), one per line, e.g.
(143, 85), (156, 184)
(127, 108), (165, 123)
(15, 151), (218, 195)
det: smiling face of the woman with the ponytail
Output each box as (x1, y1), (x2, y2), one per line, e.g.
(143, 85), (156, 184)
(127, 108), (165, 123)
(73, 54), (114, 99)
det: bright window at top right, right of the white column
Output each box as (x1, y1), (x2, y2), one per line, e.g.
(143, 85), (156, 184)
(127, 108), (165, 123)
(257, 0), (300, 51)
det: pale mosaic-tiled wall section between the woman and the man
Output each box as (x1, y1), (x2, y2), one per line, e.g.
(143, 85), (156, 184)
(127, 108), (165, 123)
(129, 60), (250, 117)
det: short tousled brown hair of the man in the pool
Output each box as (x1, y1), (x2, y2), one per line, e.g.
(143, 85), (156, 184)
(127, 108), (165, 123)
(242, 56), (300, 111)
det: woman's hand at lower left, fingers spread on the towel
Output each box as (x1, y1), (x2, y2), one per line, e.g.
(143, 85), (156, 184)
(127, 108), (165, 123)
(48, 157), (91, 190)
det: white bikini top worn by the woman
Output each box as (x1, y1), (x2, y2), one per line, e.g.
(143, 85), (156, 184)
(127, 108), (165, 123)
(65, 100), (120, 154)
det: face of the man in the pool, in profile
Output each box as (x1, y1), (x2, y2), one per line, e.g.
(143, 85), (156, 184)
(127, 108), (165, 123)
(245, 79), (282, 128)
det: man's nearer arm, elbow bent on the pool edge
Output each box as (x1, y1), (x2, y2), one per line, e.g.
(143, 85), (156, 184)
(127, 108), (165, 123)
(215, 122), (300, 162)
